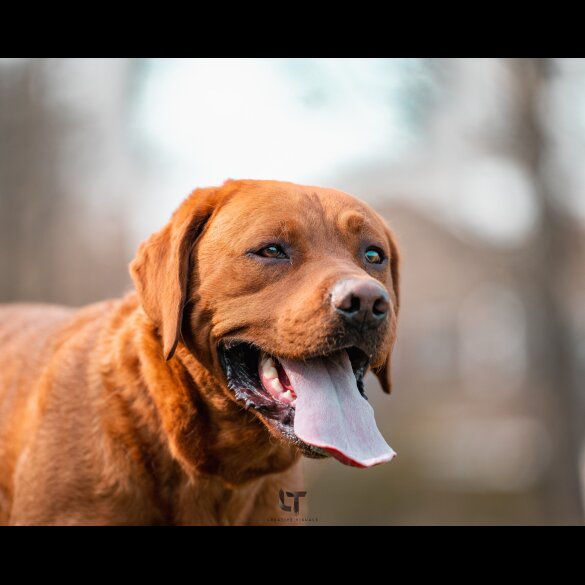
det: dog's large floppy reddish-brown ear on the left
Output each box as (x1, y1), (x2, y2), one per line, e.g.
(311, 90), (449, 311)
(130, 189), (215, 360)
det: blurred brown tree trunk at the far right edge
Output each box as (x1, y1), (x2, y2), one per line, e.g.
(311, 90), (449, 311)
(508, 59), (583, 523)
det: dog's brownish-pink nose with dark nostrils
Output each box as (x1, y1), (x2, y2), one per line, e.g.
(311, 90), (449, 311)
(331, 278), (390, 324)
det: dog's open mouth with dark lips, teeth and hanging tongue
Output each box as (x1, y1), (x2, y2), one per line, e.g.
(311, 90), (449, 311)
(219, 342), (394, 467)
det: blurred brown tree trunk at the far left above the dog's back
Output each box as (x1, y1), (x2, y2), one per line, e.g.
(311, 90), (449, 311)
(0, 61), (67, 301)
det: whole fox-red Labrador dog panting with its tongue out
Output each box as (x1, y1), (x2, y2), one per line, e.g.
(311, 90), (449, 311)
(0, 181), (398, 524)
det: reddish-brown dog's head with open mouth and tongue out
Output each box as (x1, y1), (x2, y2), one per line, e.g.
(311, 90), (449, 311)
(131, 181), (399, 467)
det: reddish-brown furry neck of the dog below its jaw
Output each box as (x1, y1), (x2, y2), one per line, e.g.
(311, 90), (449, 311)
(126, 298), (300, 488)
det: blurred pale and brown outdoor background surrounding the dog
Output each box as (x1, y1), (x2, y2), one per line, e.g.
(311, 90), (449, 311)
(0, 59), (585, 524)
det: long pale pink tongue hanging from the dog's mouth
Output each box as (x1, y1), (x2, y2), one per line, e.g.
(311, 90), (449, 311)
(280, 351), (395, 467)
